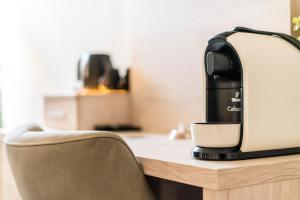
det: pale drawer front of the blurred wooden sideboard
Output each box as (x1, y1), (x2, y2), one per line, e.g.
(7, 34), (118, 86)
(44, 97), (78, 130)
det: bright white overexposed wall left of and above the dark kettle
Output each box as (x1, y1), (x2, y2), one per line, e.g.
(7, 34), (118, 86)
(0, 0), (129, 128)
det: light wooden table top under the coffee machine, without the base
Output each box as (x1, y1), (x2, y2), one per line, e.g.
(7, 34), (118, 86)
(120, 134), (300, 190)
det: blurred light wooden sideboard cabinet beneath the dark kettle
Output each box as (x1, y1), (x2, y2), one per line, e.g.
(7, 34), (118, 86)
(44, 93), (131, 130)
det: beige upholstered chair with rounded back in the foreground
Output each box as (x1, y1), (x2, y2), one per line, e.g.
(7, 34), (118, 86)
(5, 125), (155, 200)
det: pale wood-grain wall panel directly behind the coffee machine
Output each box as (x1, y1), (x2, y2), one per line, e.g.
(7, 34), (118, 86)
(130, 0), (290, 132)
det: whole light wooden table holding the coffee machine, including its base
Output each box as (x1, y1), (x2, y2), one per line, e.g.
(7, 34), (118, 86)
(121, 134), (300, 200)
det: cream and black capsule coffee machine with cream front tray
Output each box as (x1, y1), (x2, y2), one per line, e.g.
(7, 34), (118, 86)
(191, 27), (300, 160)
